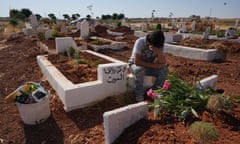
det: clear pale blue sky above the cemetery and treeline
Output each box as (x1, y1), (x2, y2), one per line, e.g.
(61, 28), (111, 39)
(0, 0), (240, 18)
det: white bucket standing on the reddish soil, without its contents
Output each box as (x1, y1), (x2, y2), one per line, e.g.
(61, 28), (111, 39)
(16, 95), (51, 125)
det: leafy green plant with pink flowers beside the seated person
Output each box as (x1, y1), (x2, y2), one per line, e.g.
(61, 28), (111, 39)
(147, 75), (215, 120)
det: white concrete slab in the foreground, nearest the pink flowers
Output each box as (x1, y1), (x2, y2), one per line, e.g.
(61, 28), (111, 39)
(103, 102), (148, 144)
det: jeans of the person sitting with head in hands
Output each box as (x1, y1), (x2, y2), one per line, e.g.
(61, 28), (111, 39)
(130, 64), (168, 101)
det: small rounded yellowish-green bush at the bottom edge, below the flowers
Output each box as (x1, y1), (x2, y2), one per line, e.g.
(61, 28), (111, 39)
(189, 121), (218, 144)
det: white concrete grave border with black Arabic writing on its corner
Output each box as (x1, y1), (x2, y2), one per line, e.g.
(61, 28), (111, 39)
(37, 50), (127, 112)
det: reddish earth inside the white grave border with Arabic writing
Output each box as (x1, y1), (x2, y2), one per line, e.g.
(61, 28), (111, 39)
(47, 52), (110, 84)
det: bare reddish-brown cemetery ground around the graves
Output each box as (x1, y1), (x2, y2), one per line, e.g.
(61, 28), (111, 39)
(0, 25), (240, 144)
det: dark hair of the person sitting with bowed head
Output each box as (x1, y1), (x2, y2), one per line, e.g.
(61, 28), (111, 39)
(147, 30), (165, 48)
